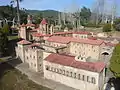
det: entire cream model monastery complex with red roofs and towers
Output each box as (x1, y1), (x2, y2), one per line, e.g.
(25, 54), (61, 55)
(15, 16), (118, 90)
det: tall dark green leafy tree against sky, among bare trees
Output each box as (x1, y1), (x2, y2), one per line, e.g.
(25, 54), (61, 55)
(80, 7), (91, 24)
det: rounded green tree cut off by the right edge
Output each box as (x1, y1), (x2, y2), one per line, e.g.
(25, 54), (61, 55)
(110, 44), (120, 77)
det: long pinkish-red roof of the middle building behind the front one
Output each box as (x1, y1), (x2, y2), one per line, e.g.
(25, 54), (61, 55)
(47, 36), (104, 45)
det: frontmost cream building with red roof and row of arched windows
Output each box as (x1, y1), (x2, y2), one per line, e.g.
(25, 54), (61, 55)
(43, 54), (105, 90)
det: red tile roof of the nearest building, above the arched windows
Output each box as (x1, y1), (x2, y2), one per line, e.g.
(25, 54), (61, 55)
(45, 54), (105, 72)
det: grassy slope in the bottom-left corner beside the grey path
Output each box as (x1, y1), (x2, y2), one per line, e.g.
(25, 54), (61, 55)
(0, 63), (50, 90)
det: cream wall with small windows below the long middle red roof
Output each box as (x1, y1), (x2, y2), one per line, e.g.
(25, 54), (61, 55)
(70, 42), (100, 60)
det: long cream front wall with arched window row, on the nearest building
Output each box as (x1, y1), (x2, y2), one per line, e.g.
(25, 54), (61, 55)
(43, 61), (103, 90)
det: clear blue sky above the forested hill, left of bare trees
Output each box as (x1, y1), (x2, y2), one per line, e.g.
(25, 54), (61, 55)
(0, 0), (95, 11)
